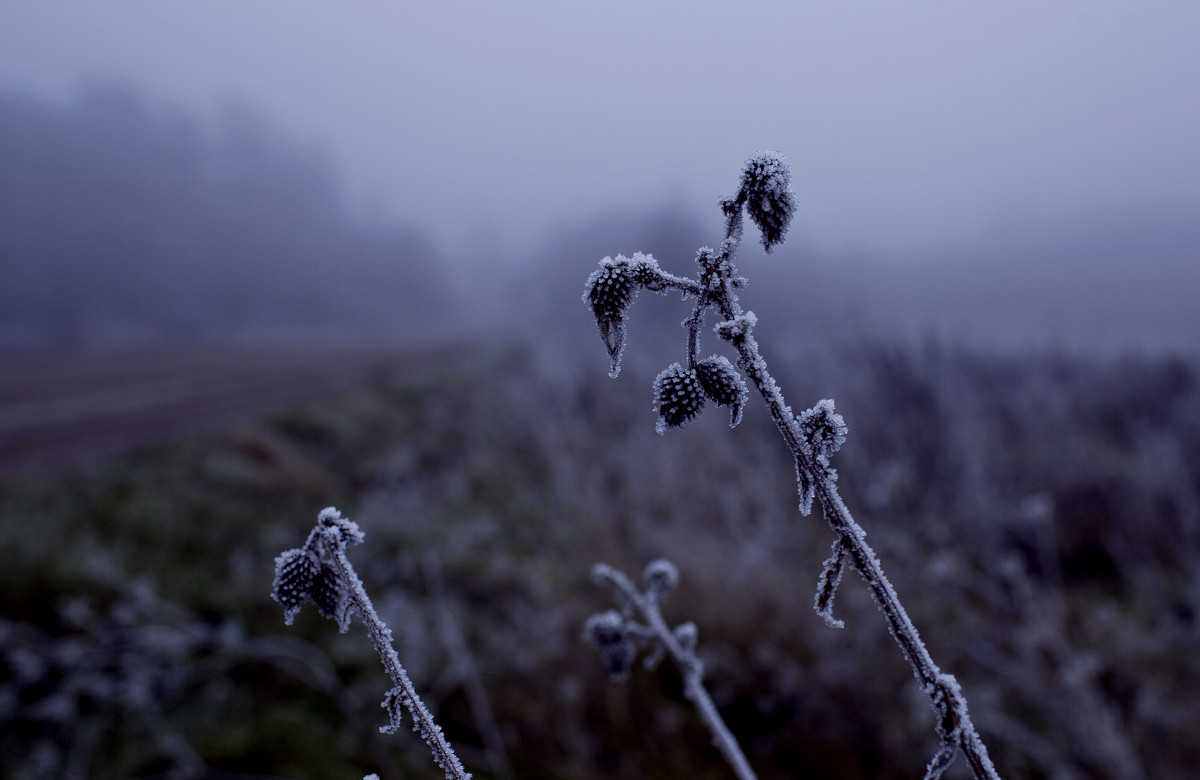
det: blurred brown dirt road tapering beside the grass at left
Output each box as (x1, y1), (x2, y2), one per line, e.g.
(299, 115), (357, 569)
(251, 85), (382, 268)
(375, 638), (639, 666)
(0, 349), (414, 480)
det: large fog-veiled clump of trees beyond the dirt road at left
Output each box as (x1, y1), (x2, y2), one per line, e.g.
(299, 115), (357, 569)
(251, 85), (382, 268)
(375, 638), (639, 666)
(0, 84), (448, 350)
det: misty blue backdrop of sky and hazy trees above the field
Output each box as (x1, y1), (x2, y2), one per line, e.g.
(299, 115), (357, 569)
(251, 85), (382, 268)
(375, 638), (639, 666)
(0, 2), (1200, 352)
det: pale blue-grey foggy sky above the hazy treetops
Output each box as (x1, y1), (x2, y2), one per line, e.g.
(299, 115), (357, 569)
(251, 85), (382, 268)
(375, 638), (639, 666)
(0, 0), (1200, 248)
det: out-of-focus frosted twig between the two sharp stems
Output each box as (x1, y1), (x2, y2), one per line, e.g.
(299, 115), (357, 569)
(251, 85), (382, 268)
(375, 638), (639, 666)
(583, 558), (756, 780)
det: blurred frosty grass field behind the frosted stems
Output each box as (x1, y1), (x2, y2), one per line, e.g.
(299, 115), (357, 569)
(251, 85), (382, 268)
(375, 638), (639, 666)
(0, 344), (1200, 778)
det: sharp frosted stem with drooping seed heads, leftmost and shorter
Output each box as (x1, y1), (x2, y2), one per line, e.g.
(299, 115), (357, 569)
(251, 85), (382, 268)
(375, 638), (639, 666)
(271, 506), (470, 780)
